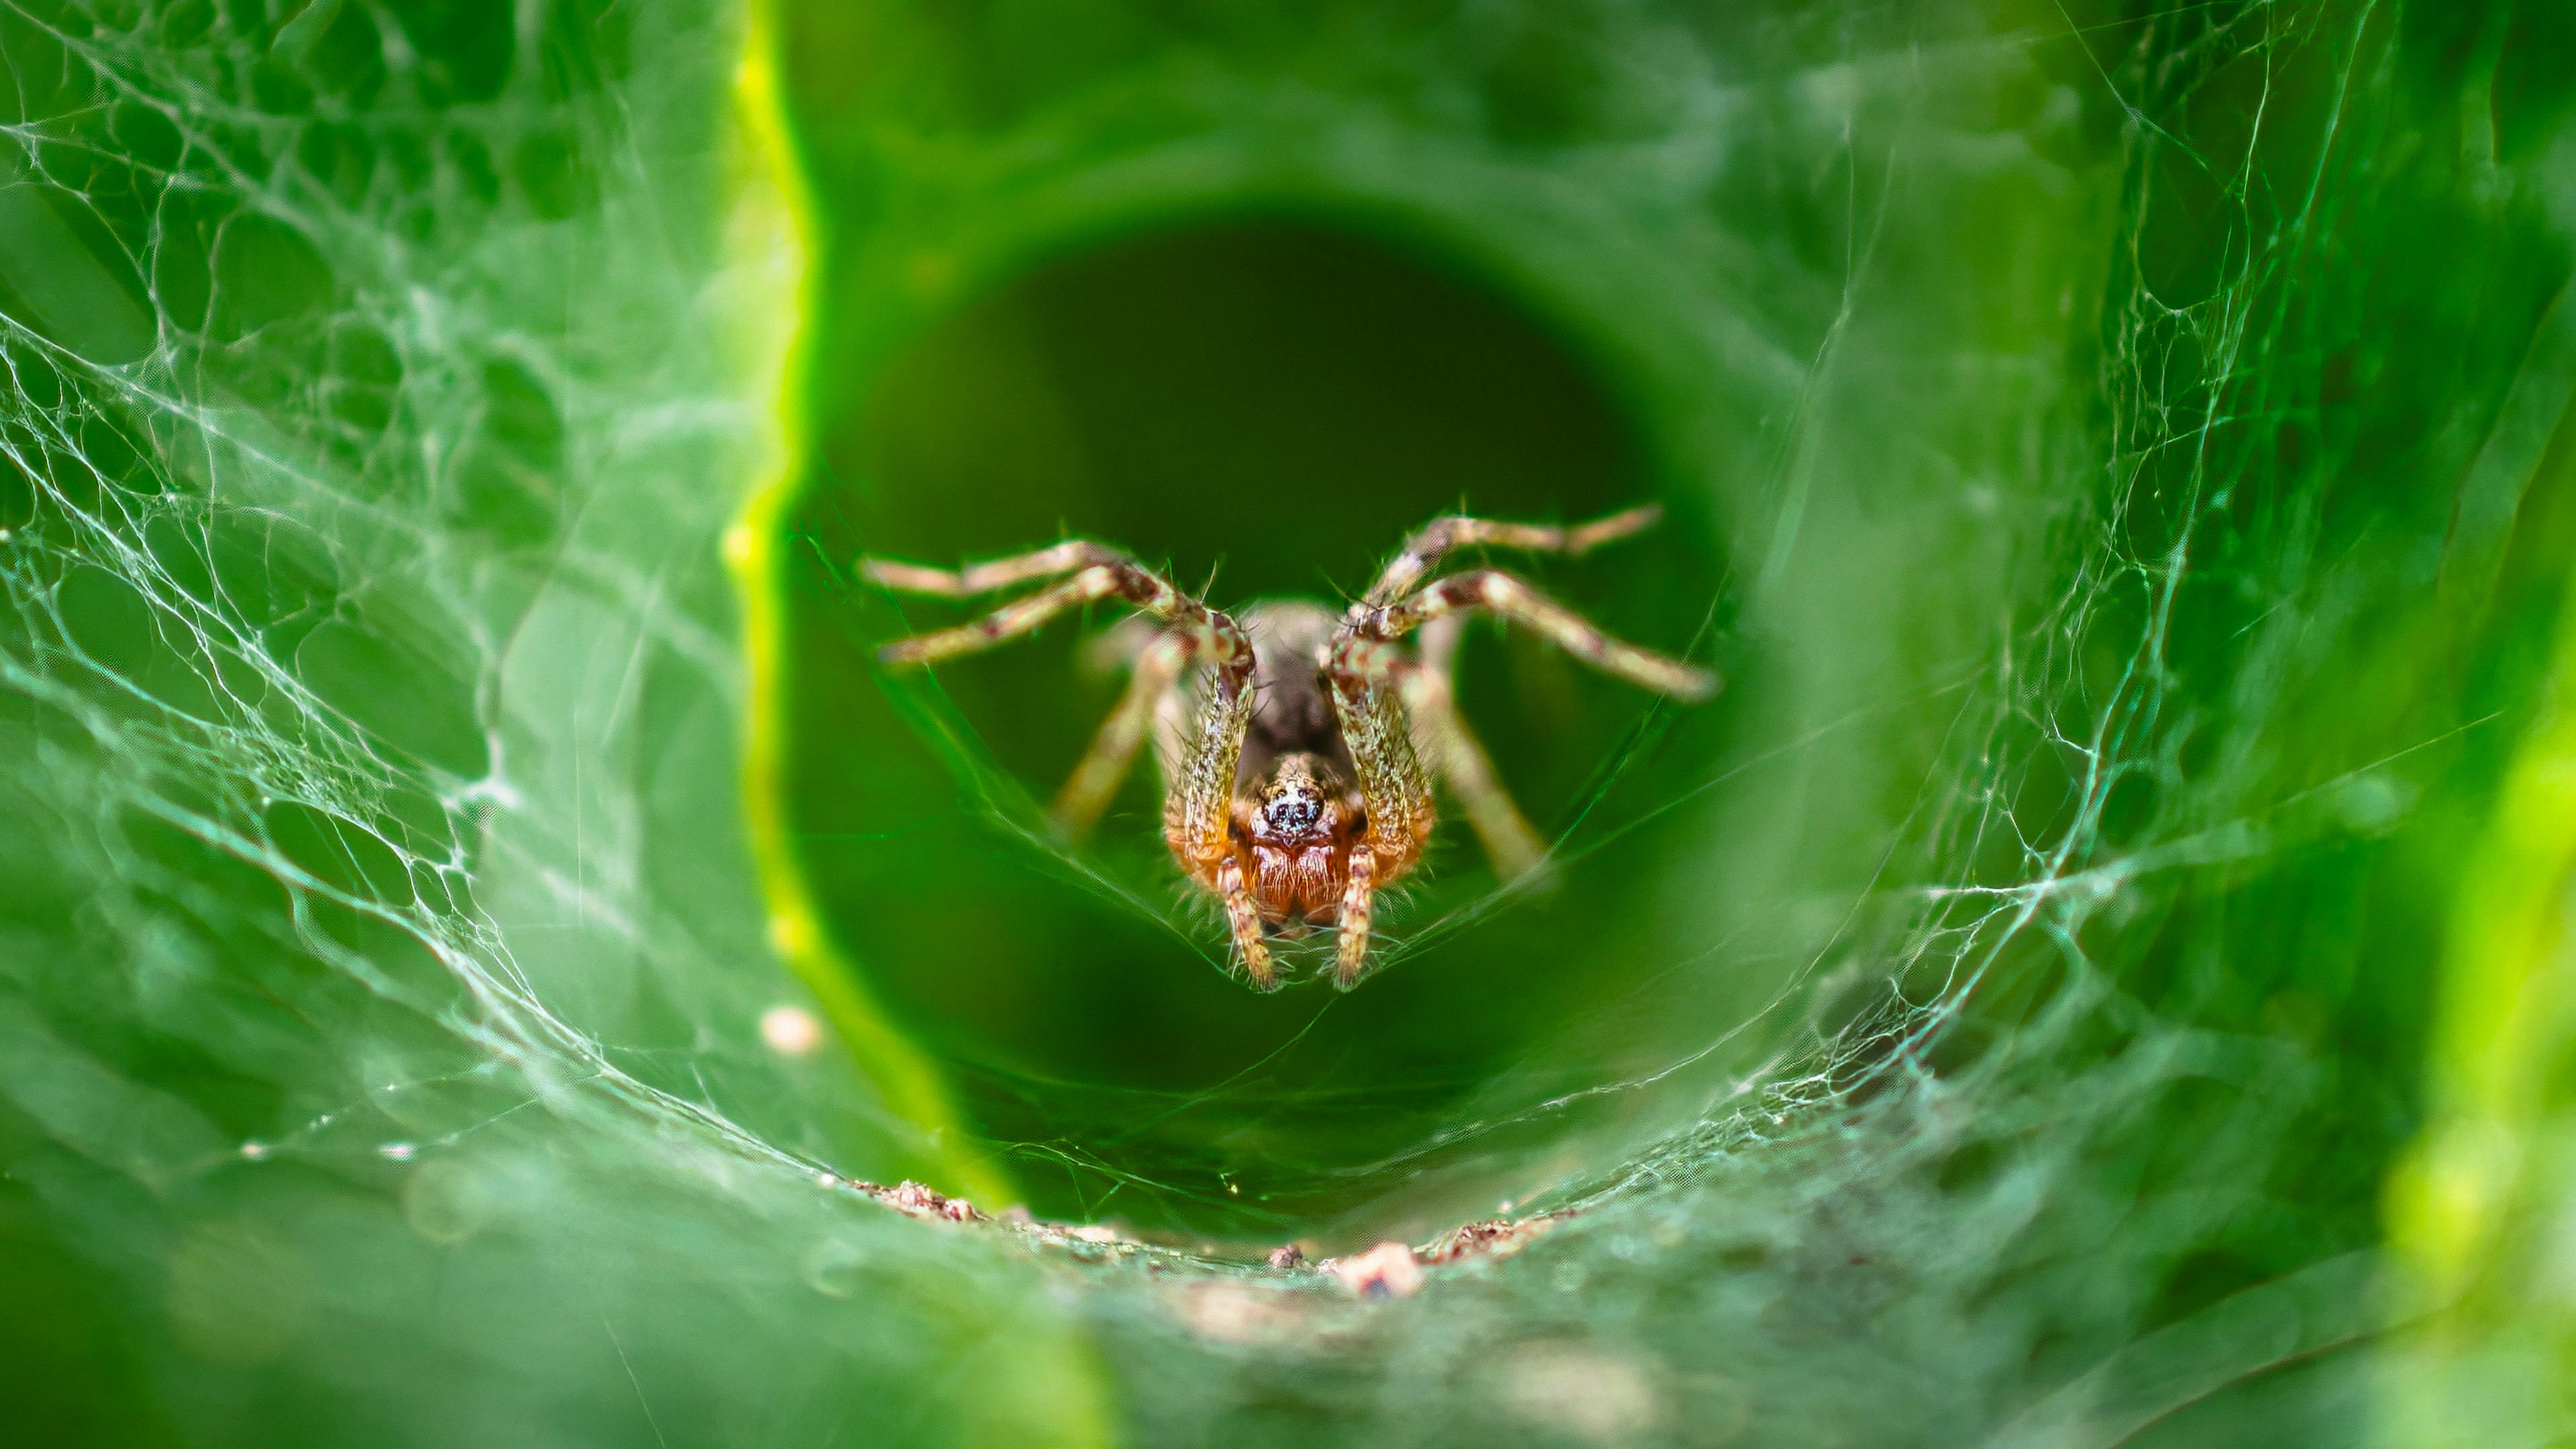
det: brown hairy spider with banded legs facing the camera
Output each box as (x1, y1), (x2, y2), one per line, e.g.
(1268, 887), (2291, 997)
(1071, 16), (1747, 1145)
(861, 505), (1718, 990)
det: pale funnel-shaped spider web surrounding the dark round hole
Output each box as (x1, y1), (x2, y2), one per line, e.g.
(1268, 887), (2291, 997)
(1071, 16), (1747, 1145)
(0, 0), (2571, 1444)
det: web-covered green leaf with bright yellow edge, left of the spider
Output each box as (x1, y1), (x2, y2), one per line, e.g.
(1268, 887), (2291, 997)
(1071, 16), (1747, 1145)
(0, 3), (1097, 1444)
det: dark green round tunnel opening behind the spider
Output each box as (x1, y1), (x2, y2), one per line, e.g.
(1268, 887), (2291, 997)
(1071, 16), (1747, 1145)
(762, 219), (1718, 1235)
